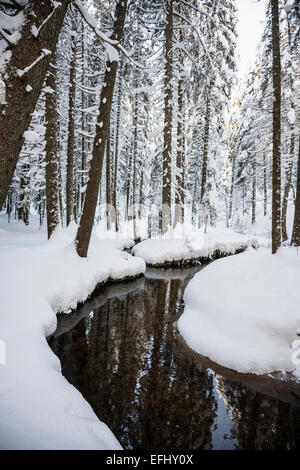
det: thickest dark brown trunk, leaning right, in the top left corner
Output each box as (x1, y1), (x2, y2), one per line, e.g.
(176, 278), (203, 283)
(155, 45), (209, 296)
(0, 0), (69, 208)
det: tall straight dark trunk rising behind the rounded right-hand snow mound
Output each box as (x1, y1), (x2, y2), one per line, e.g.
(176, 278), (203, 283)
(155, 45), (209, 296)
(271, 0), (281, 254)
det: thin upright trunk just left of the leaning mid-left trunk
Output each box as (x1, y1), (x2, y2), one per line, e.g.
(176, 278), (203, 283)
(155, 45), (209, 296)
(66, 36), (77, 225)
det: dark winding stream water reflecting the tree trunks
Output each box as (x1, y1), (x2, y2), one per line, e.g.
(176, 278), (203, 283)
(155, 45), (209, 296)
(49, 268), (300, 450)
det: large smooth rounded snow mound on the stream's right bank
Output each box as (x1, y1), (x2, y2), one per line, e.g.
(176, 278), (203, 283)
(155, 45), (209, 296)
(178, 248), (300, 378)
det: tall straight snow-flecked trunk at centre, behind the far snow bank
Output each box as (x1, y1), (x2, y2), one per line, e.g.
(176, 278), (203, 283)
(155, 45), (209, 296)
(162, 0), (174, 234)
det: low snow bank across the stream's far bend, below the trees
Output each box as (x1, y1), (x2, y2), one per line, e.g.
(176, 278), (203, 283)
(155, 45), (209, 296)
(132, 229), (268, 266)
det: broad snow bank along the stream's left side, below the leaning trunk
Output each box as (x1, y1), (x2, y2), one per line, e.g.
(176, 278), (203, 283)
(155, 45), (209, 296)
(0, 216), (145, 449)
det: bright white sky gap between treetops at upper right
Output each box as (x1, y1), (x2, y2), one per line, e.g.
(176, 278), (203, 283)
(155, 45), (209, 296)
(236, 0), (267, 76)
